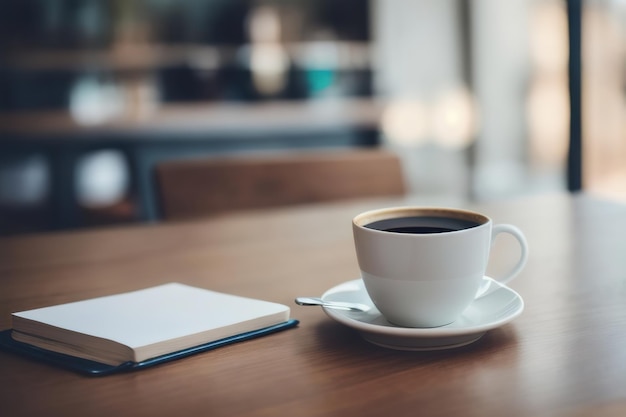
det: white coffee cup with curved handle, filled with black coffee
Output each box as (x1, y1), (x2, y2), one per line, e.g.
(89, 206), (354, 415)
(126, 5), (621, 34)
(352, 207), (528, 327)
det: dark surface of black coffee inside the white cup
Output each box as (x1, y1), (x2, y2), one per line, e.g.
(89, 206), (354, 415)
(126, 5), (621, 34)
(365, 216), (481, 234)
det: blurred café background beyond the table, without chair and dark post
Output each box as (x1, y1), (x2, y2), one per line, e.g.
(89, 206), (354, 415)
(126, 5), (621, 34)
(0, 0), (626, 235)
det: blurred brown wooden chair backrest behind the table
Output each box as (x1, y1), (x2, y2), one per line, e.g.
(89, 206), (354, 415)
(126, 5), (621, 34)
(156, 149), (406, 220)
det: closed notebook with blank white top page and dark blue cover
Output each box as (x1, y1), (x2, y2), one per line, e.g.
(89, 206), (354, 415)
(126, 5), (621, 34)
(0, 283), (298, 374)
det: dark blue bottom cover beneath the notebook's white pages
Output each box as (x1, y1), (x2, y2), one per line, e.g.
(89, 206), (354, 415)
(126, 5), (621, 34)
(0, 319), (299, 376)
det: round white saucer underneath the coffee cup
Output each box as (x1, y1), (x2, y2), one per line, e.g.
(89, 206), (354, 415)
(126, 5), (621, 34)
(322, 277), (524, 350)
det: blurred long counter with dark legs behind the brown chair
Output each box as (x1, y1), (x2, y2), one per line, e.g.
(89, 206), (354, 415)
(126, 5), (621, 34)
(0, 99), (383, 229)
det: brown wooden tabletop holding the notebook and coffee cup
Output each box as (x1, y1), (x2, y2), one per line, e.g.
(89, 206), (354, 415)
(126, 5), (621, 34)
(0, 195), (626, 417)
